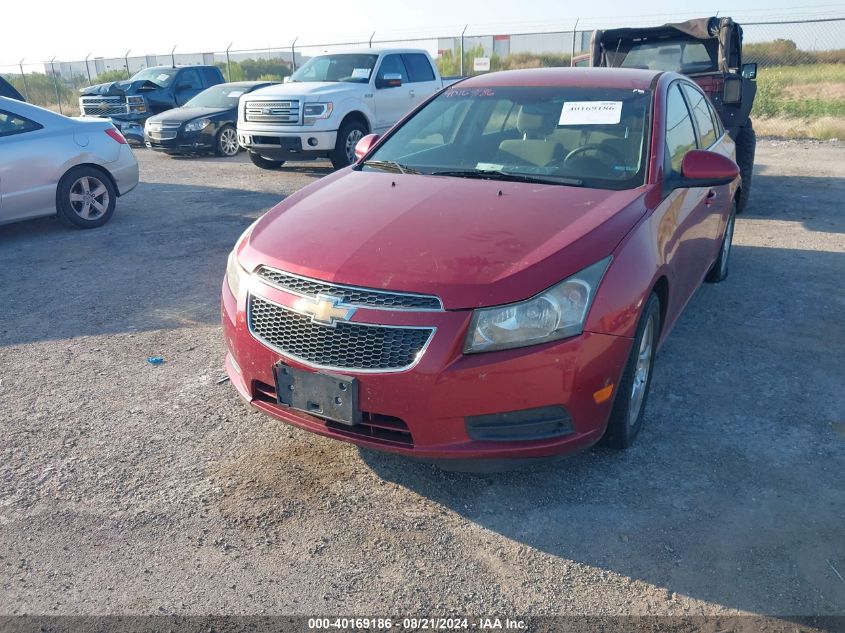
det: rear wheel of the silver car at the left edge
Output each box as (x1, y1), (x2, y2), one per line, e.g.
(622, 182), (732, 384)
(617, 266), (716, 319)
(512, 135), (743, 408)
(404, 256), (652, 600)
(56, 165), (117, 229)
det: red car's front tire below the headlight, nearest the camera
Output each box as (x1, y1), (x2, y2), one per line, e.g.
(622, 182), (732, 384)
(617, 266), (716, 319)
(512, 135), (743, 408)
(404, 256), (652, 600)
(602, 293), (660, 450)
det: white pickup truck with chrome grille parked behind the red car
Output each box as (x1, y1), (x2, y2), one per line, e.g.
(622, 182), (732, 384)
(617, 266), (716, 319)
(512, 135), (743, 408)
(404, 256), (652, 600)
(238, 48), (457, 169)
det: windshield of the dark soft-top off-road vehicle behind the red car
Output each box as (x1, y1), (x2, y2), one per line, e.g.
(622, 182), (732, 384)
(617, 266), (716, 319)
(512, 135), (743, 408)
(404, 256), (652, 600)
(607, 38), (719, 75)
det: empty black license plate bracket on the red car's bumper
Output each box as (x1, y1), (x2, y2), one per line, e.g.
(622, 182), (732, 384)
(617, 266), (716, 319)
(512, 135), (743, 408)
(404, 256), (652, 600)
(273, 363), (361, 426)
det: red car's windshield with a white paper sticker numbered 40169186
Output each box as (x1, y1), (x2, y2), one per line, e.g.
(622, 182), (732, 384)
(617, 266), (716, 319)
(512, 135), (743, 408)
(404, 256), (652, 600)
(363, 87), (651, 189)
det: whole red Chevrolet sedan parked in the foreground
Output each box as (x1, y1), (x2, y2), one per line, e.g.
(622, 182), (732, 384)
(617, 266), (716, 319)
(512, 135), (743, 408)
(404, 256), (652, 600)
(222, 68), (739, 459)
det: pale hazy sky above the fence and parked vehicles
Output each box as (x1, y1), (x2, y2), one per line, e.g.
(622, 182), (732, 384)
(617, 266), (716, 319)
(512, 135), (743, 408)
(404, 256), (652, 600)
(0, 0), (845, 66)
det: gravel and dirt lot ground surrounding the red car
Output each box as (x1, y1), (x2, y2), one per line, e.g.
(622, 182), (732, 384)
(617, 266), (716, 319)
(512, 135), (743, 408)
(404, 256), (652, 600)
(0, 141), (845, 615)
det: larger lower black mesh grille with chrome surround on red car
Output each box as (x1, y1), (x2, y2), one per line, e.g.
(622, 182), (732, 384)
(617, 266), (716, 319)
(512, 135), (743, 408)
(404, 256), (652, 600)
(247, 295), (434, 371)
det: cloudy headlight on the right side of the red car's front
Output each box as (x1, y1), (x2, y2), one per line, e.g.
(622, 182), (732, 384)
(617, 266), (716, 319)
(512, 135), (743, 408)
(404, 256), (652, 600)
(464, 257), (611, 354)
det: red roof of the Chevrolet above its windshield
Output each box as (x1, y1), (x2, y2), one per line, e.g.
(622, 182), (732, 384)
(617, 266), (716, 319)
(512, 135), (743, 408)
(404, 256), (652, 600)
(456, 68), (663, 90)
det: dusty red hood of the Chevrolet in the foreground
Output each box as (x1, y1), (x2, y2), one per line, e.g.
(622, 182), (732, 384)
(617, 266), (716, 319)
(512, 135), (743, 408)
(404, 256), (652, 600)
(239, 169), (646, 309)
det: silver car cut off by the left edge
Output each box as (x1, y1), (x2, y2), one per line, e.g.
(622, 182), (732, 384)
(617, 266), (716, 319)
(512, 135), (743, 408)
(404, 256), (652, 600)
(0, 97), (138, 228)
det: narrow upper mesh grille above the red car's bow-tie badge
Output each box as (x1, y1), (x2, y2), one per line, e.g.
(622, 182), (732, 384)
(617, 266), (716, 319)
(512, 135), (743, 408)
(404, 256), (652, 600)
(256, 266), (443, 310)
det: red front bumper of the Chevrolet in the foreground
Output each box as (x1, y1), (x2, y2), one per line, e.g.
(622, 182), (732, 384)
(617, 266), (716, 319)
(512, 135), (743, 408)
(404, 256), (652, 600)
(221, 272), (632, 459)
